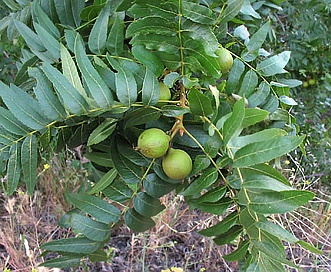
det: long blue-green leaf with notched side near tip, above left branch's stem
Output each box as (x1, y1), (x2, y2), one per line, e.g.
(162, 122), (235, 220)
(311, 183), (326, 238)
(29, 68), (67, 120)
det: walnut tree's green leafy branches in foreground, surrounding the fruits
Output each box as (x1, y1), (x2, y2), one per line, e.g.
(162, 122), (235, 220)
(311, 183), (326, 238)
(0, 0), (319, 271)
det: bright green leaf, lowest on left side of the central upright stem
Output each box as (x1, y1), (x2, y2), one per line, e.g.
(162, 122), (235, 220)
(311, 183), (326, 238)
(131, 44), (164, 77)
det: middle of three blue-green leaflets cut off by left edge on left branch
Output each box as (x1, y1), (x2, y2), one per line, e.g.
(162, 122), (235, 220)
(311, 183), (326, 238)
(0, 106), (29, 136)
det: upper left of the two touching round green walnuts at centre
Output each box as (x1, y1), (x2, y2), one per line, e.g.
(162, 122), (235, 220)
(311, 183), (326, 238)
(137, 128), (170, 159)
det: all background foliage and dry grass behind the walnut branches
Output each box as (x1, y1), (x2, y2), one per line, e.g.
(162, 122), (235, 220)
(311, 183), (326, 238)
(0, 1), (331, 271)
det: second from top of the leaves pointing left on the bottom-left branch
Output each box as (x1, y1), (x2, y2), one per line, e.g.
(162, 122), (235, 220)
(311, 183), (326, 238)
(69, 213), (110, 242)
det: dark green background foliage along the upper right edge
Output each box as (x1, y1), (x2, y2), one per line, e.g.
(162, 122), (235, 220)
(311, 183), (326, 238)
(277, 0), (331, 187)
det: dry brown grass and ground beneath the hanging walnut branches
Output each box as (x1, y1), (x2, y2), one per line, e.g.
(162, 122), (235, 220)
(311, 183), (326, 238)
(0, 152), (331, 272)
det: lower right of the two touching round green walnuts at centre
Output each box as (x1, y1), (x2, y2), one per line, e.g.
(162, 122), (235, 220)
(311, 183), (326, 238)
(162, 148), (192, 179)
